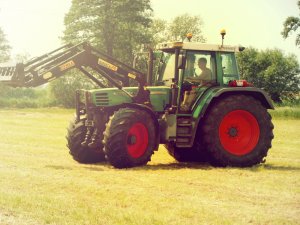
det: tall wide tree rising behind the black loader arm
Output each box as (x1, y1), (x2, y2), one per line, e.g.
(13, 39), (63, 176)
(63, 0), (152, 63)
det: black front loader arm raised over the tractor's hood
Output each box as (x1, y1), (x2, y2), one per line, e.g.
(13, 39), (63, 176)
(0, 42), (149, 102)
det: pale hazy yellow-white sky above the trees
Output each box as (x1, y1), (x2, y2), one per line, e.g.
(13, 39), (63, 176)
(0, 0), (300, 62)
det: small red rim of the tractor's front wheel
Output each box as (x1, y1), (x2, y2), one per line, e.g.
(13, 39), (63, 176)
(127, 123), (148, 158)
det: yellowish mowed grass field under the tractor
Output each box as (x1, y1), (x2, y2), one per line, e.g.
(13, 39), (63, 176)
(0, 109), (300, 225)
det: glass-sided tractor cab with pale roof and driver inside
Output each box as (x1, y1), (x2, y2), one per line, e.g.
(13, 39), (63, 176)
(155, 42), (243, 112)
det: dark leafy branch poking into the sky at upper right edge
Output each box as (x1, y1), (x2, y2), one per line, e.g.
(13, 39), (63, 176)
(281, 0), (300, 46)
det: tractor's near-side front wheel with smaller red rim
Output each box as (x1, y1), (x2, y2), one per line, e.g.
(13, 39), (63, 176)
(104, 108), (157, 168)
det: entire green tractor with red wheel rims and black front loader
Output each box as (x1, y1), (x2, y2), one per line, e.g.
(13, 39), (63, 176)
(0, 33), (274, 168)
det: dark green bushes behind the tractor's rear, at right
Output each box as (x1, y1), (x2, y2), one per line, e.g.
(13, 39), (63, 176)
(237, 48), (300, 102)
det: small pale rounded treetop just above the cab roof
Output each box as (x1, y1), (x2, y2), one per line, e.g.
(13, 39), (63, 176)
(168, 14), (206, 42)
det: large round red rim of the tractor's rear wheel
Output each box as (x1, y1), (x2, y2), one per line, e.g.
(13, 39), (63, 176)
(219, 110), (260, 156)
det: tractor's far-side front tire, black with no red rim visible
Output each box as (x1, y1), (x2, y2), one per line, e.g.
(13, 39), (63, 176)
(66, 119), (106, 164)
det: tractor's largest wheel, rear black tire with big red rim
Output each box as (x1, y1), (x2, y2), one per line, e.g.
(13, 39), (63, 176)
(202, 95), (274, 167)
